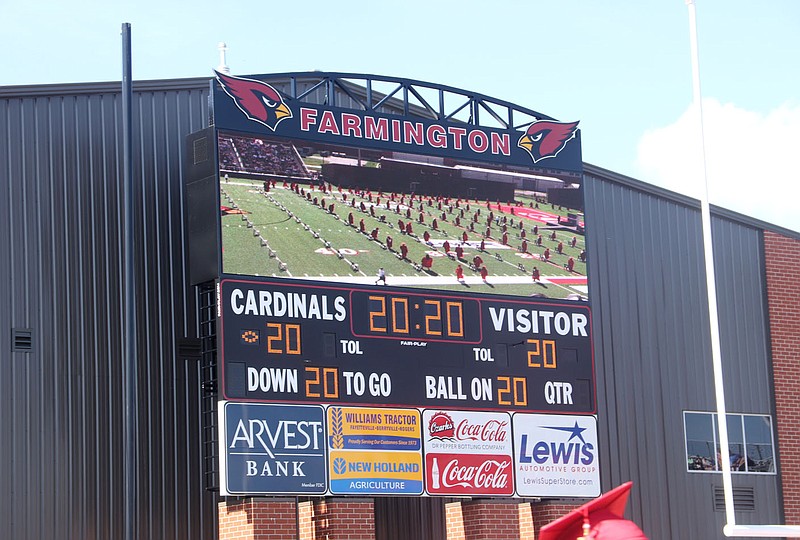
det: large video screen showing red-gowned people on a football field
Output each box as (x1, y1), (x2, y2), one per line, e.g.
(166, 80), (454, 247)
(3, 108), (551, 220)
(218, 132), (588, 301)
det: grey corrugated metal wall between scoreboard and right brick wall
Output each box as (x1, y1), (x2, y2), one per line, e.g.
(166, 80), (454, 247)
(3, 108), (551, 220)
(585, 167), (781, 539)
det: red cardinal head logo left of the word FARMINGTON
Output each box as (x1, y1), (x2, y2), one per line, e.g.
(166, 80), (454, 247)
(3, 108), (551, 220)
(214, 71), (292, 131)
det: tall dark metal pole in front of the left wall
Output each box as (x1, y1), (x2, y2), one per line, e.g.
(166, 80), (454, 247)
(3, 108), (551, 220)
(122, 23), (138, 540)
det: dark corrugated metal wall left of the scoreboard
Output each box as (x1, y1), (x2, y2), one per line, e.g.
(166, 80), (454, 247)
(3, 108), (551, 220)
(0, 79), (216, 539)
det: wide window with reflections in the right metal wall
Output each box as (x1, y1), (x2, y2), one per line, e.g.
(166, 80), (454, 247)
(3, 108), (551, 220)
(683, 411), (775, 474)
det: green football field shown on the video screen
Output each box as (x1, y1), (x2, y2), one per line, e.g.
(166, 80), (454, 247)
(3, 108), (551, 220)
(220, 178), (586, 298)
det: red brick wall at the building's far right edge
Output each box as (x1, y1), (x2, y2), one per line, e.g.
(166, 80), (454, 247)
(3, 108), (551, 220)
(764, 231), (800, 523)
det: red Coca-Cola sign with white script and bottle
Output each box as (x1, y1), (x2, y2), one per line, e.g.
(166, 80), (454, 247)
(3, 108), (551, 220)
(428, 454), (514, 495)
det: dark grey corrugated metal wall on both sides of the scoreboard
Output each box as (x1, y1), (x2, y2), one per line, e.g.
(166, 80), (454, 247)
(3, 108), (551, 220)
(0, 79), (780, 539)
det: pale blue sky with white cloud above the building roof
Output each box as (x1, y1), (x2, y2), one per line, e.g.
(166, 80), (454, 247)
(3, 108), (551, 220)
(6, 0), (800, 231)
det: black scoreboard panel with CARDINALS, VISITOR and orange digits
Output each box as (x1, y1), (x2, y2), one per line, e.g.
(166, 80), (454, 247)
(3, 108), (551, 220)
(218, 277), (595, 414)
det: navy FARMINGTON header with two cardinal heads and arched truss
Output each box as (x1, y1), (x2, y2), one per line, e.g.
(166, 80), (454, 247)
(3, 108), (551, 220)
(213, 73), (583, 173)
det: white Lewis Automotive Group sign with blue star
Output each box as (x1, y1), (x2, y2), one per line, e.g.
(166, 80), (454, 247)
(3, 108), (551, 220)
(513, 413), (600, 497)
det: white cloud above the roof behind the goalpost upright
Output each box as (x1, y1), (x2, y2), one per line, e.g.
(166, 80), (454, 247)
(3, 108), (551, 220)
(638, 99), (800, 231)
